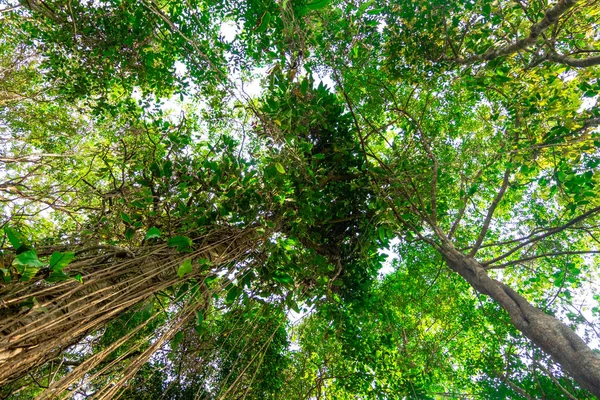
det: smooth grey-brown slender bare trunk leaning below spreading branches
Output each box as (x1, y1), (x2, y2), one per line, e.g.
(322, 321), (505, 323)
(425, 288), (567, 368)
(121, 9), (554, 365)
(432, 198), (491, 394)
(439, 240), (600, 398)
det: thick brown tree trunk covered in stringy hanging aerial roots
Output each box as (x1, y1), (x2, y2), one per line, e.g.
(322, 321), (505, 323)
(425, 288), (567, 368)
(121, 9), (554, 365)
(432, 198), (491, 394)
(0, 230), (256, 385)
